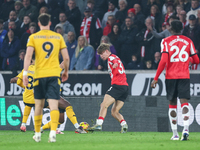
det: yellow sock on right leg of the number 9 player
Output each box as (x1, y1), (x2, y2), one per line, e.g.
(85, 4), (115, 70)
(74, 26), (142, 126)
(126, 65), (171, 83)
(50, 110), (60, 131)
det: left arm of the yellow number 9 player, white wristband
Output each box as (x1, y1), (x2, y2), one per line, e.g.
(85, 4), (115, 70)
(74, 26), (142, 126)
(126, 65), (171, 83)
(23, 46), (34, 86)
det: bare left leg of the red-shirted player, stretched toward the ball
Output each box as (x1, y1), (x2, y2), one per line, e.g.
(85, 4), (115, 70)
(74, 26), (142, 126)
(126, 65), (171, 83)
(87, 94), (115, 131)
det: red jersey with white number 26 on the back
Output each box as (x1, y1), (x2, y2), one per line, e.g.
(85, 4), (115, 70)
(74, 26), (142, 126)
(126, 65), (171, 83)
(161, 35), (196, 79)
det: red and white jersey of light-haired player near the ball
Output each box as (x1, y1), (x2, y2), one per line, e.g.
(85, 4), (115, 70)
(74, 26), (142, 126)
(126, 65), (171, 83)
(108, 54), (128, 86)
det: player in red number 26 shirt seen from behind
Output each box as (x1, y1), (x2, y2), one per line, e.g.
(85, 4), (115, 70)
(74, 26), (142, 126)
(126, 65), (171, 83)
(151, 20), (199, 141)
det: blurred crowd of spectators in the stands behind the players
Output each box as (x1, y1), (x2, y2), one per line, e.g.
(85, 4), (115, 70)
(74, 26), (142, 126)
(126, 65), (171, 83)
(0, 0), (200, 75)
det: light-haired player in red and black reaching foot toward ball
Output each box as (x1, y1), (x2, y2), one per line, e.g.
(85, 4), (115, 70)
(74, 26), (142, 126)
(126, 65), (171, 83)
(87, 43), (128, 133)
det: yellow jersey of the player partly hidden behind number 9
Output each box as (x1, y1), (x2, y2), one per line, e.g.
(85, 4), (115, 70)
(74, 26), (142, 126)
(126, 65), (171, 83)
(17, 65), (35, 104)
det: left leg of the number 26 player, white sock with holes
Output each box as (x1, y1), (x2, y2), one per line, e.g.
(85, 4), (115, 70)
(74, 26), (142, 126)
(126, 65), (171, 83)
(168, 98), (179, 140)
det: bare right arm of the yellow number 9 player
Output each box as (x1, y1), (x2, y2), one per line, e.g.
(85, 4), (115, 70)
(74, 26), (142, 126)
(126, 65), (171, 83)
(61, 48), (70, 82)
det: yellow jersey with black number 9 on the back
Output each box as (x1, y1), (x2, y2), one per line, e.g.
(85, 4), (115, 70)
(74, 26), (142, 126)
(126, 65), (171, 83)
(27, 30), (66, 79)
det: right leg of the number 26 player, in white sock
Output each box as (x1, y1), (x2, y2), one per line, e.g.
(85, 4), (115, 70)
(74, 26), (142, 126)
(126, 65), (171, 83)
(180, 99), (190, 141)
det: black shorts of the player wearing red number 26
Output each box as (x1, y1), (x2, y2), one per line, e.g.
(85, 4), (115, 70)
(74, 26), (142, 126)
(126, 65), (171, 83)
(165, 79), (190, 100)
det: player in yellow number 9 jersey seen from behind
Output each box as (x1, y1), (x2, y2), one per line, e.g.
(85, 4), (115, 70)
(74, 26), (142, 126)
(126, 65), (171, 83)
(23, 13), (69, 142)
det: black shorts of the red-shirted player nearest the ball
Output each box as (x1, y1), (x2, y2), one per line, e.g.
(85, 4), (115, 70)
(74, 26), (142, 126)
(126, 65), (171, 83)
(106, 84), (128, 102)
